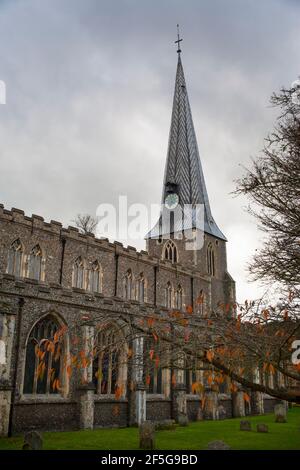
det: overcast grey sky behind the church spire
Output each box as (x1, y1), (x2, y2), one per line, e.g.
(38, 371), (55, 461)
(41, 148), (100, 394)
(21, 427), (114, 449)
(0, 0), (300, 300)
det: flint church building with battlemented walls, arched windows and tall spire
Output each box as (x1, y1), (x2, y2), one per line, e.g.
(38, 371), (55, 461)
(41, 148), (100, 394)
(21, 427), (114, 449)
(0, 46), (274, 435)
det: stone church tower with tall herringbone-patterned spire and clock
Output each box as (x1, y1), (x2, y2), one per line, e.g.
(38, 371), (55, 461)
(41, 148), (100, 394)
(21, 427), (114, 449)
(146, 48), (235, 308)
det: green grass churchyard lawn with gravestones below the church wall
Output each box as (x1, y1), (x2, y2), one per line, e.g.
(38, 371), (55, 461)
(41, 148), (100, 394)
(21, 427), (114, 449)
(0, 407), (300, 450)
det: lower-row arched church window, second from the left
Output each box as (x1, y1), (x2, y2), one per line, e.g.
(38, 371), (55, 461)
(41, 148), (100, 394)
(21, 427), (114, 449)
(93, 326), (126, 395)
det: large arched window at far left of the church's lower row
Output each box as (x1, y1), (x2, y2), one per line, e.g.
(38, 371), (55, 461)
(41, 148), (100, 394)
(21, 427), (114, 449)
(23, 315), (64, 394)
